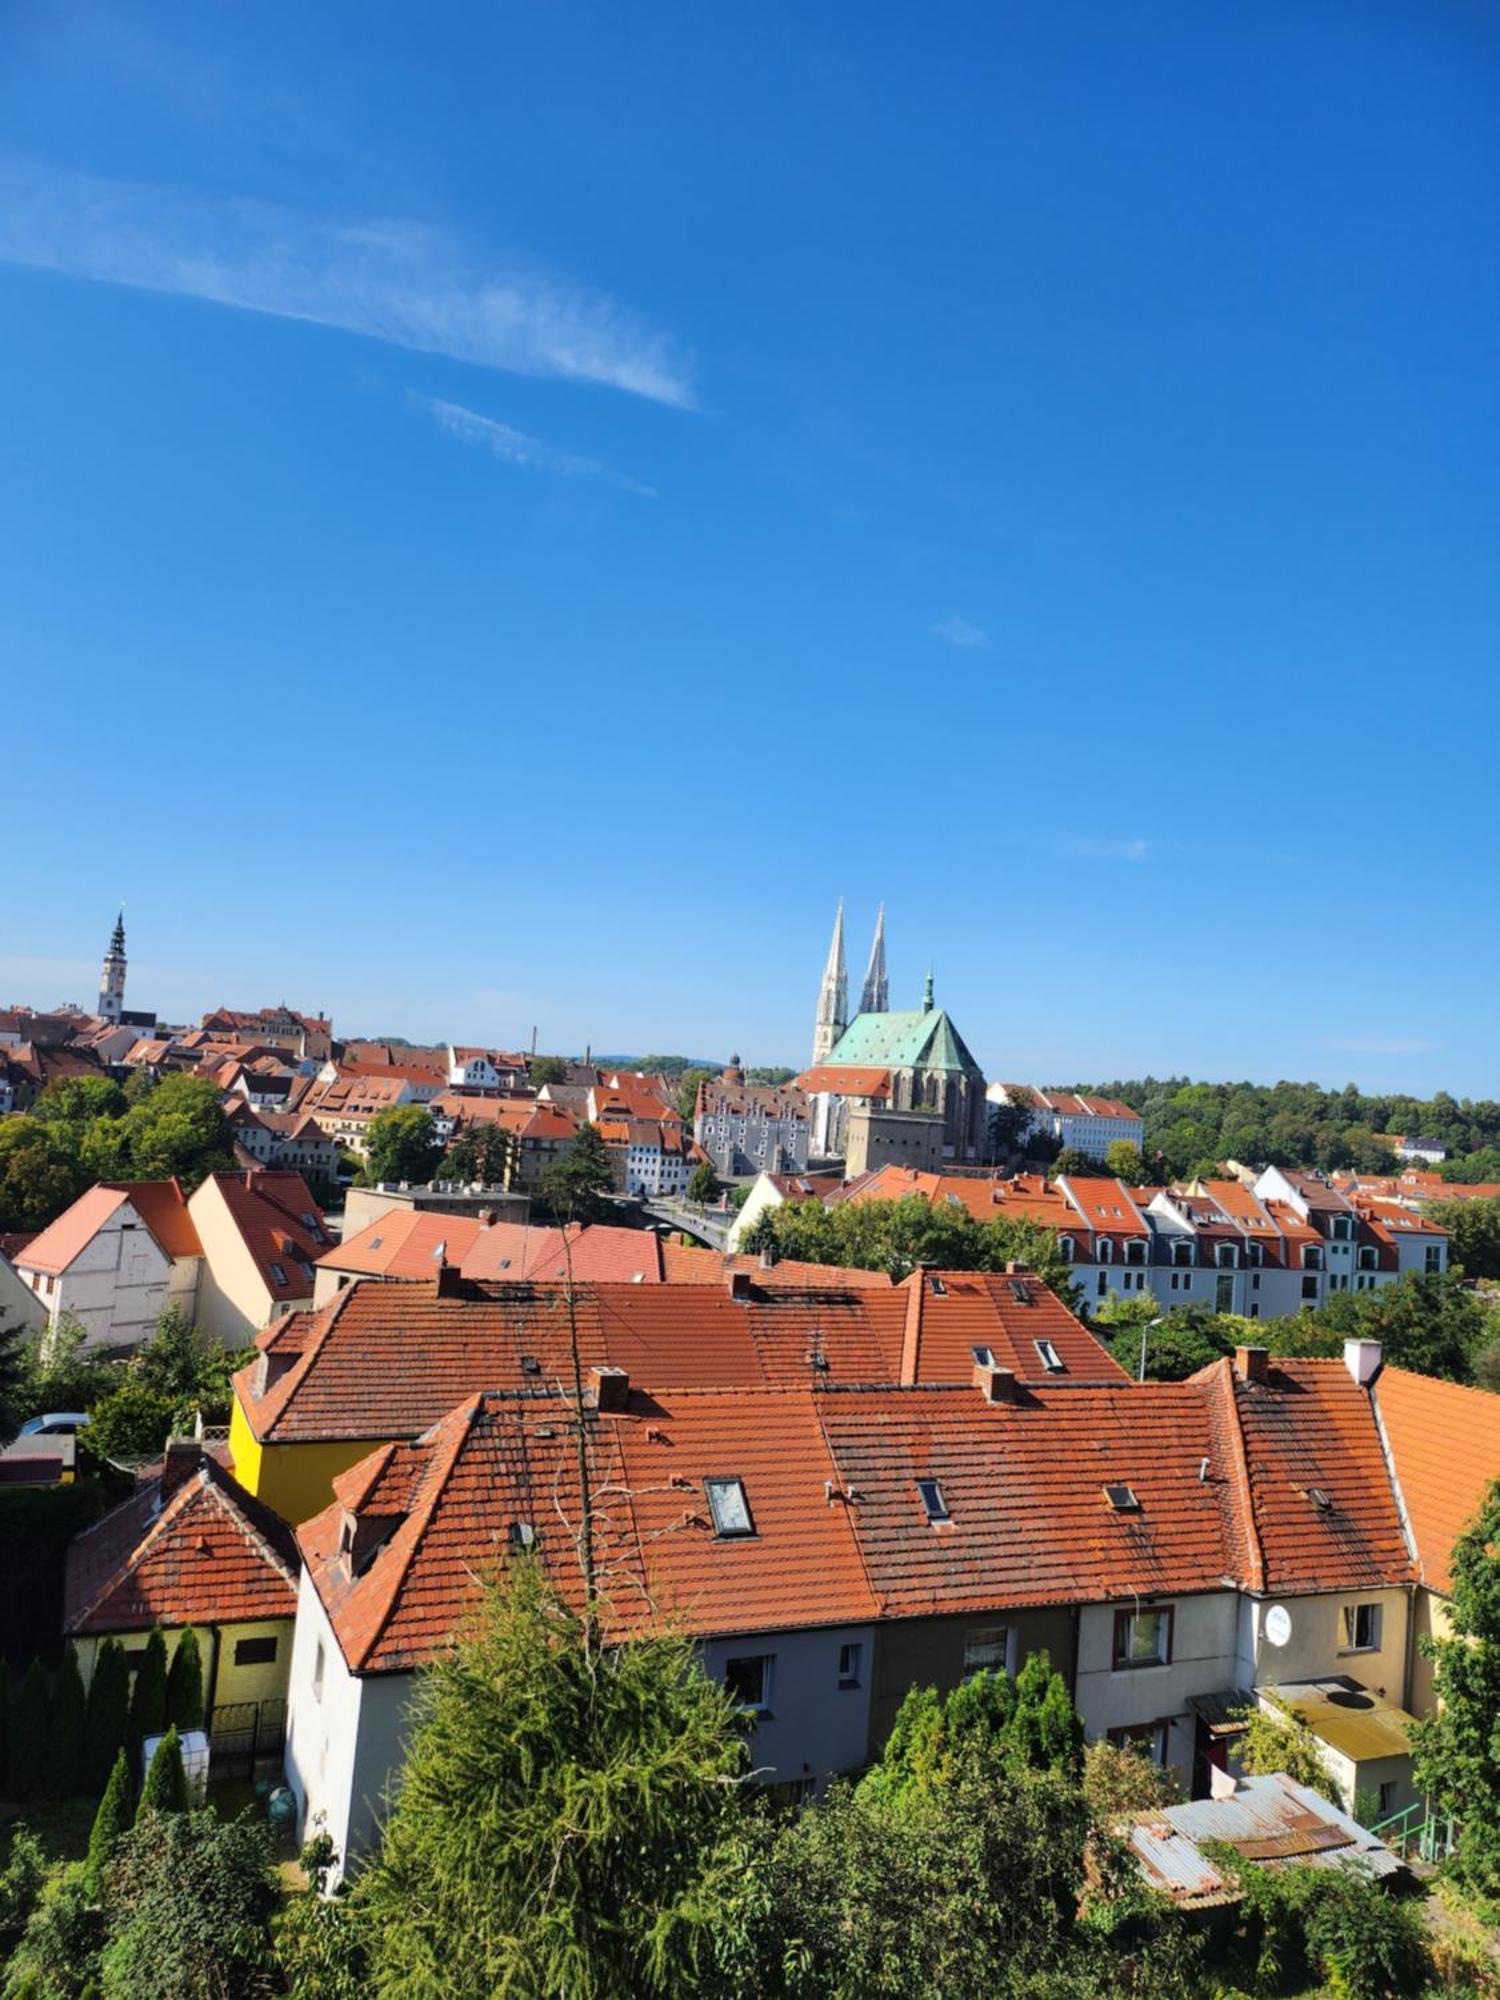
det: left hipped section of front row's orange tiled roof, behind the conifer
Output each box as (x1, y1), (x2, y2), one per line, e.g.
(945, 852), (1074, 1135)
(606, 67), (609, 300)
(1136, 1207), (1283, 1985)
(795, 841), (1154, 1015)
(298, 1390), (874, 1672)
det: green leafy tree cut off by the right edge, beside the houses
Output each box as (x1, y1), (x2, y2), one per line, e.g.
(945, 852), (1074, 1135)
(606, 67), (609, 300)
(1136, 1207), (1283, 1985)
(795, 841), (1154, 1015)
(1414, 1480), (1500, 1900)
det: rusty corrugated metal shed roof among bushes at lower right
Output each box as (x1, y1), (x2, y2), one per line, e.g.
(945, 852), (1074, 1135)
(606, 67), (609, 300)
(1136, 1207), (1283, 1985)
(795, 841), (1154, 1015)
(1130, 1772), (1400, 1908)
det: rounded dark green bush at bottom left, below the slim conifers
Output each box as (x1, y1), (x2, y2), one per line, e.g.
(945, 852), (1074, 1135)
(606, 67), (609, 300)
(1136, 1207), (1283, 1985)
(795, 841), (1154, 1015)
(100, 1810), (278, 2000)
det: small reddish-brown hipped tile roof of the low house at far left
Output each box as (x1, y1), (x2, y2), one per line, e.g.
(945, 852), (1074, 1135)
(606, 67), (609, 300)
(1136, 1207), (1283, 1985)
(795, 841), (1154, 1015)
(62, 1456), (298, 1636)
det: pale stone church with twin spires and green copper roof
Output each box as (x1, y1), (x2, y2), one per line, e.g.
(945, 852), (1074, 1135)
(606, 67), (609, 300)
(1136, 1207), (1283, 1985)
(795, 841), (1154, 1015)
(798, 902), (988, 1176)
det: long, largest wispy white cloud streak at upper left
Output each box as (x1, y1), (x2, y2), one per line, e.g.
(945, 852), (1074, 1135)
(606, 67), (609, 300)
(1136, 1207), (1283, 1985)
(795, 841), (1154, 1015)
(0, 164), (694, 408)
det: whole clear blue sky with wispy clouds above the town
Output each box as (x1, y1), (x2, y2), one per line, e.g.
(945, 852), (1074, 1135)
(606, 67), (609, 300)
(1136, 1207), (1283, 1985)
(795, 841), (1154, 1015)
(0, 0), (1500, 1094)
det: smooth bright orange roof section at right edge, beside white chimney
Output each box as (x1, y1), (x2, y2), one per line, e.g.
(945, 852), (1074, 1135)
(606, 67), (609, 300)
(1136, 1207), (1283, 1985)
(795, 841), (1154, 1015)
(1374, 1368), (1500, 1594)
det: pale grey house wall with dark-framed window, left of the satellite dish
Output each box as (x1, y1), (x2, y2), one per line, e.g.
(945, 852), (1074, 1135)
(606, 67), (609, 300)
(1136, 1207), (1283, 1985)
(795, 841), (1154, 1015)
(1074, 1590), (1240, 1788)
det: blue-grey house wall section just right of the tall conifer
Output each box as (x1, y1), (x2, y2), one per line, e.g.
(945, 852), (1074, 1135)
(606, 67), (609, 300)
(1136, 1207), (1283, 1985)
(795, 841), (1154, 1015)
(702, 1626), (874, 1792)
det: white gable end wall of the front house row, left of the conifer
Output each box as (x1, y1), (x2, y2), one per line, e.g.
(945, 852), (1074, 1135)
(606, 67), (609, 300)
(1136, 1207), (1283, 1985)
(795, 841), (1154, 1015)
(286, 1570), (414, 1864)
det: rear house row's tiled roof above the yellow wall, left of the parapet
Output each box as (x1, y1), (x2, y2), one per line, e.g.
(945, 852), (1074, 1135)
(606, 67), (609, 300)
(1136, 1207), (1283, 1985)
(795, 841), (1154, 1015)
(234, 1280), (906, 1444)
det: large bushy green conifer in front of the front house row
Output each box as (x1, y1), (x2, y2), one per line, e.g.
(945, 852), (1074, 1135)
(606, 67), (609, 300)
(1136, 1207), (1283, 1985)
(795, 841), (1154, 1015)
(362, 1560), (744, 2000)
